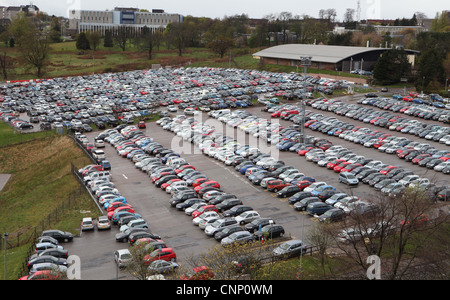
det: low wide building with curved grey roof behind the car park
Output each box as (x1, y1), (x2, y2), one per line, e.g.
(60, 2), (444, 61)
(253, 44), (417, 72)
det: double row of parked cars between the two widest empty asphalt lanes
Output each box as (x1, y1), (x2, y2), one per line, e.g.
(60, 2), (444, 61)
(106, 122), (284, 245)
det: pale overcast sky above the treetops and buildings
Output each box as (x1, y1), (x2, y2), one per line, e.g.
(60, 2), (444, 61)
(0, 0), (450, 20)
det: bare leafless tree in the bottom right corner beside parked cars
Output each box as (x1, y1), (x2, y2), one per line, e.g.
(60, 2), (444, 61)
(327, 188), (448, 280)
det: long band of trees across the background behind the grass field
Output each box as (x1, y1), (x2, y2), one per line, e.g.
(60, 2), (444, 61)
(0, 9), (450, 90)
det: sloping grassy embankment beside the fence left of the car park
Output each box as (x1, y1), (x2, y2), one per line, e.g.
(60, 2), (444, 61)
(0, 123), (99, 279)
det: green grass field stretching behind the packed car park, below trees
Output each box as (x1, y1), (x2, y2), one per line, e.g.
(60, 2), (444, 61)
(0, 41), (372, 80)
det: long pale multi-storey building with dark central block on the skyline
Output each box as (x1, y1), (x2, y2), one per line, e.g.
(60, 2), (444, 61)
(69, 7), (183, 34)
